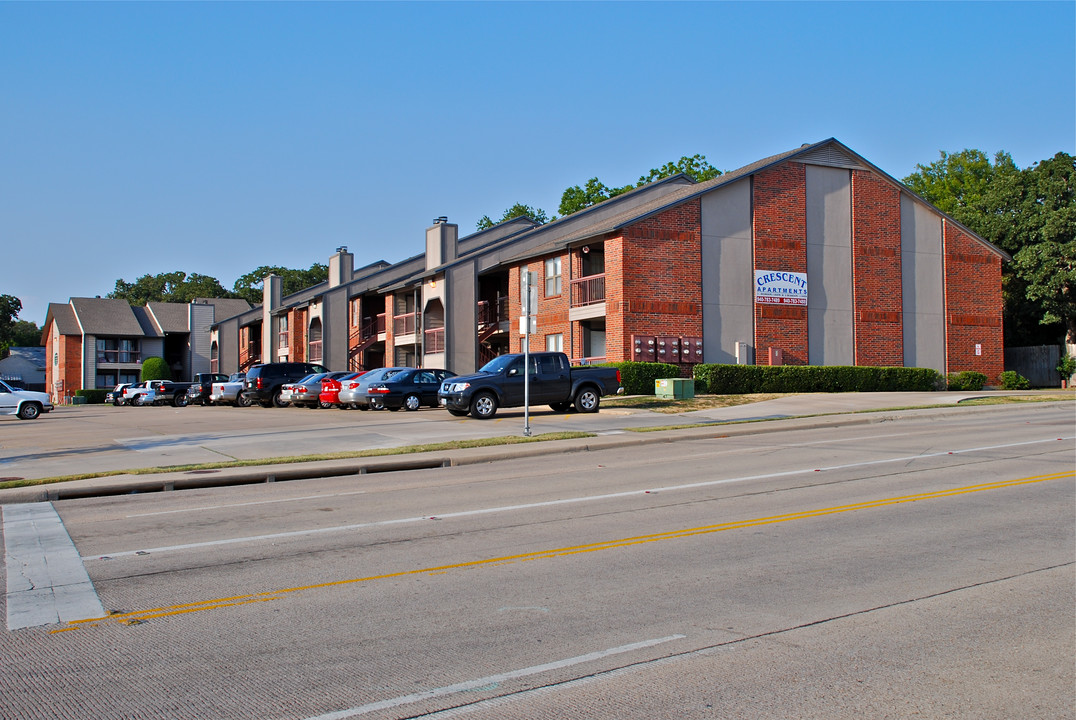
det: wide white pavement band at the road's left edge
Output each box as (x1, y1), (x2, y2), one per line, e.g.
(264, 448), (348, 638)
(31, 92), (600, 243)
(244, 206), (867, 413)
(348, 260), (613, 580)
(3, 503), (105, 630)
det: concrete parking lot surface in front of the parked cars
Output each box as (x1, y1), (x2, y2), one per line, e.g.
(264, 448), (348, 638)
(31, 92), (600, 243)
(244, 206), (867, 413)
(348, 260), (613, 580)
(0, 405), (645, 480)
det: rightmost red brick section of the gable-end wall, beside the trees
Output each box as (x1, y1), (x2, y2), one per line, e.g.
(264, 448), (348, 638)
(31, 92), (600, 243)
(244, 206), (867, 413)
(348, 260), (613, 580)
(942, 220), (1005, 383)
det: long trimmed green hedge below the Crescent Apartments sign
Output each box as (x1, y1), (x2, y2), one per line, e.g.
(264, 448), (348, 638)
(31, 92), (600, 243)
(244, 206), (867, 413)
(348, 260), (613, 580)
(695, 364), (946, 395)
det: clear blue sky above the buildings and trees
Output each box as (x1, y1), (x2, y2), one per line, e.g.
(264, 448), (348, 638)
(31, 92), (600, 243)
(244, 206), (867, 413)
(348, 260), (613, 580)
(0, 1), (1076, 325)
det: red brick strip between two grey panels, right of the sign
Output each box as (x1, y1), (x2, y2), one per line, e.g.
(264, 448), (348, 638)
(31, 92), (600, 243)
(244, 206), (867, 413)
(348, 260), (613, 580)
(852, 170), (904, 367)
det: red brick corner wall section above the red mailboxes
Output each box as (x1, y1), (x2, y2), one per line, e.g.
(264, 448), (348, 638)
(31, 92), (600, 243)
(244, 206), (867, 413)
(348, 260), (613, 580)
(606, 199), (703, 362)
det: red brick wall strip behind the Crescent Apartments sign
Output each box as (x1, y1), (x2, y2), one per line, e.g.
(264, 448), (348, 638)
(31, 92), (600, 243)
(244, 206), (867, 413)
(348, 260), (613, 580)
(752, 163), (807, 365)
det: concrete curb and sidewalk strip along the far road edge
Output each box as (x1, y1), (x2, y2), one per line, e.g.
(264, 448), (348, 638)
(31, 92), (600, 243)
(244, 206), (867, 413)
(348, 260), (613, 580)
(0, 391), (1067, 504)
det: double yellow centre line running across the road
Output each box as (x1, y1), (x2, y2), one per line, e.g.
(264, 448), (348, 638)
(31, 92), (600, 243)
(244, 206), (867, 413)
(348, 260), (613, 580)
(52, 470), (1076, 633)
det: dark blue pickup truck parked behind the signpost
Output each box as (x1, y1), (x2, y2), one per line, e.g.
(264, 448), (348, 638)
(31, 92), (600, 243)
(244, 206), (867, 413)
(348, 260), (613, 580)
(437, 352), (623, 420)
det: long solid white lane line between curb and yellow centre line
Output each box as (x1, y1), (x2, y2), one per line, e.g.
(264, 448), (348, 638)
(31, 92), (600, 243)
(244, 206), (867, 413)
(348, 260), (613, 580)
(83, 436), (1076, 560)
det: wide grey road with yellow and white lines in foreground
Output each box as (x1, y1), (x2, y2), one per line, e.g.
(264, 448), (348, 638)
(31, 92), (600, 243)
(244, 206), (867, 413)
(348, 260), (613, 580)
(0, 405), (1076, 720)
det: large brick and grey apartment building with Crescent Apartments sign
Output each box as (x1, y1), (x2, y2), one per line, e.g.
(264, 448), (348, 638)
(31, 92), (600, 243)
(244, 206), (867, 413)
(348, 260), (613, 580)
(203, 139), (1010, 381)
